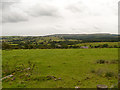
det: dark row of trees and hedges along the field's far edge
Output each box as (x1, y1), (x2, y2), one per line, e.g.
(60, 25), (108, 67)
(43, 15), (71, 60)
(2, 42), (120, 50)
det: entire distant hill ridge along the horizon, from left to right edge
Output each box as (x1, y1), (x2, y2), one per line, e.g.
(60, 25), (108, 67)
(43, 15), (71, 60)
(2, 33), (120, 41)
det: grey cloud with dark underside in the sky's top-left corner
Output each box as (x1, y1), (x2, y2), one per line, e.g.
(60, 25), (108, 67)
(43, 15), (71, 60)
(1, 0), (28, 23)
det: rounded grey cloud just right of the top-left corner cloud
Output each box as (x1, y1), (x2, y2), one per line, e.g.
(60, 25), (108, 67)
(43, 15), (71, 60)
(27, 4), (58, 17)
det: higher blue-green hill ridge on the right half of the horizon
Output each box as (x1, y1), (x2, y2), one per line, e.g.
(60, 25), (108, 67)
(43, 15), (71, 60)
(47, 33), (119, 40)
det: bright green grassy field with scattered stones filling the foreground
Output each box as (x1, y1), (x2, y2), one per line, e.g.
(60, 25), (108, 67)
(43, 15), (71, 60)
(2, 48), (118, 88)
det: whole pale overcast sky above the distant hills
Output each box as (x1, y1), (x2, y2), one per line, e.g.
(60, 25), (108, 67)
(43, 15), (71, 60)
(0, 0), (119, 36)
